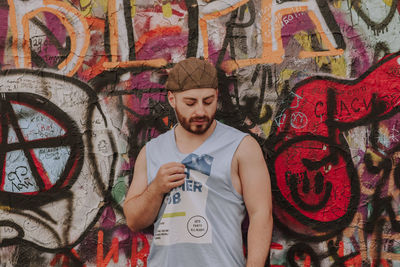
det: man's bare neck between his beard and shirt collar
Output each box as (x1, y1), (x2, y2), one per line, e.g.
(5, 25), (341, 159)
(175, 120), (217, 154)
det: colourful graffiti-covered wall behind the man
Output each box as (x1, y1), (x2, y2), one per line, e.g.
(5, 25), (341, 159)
(0, 0), (400, 267)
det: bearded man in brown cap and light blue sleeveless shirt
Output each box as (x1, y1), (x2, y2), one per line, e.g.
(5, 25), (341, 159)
(124, 58), (272, 267)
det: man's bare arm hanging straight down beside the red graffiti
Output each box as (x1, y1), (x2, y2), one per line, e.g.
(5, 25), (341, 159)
(237, 136), (273, 267)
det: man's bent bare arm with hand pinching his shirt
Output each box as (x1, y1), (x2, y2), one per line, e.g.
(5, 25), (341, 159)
(123, 147), (186, 231)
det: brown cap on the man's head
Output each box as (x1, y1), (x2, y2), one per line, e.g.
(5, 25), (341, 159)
(165, 57), (218, 91)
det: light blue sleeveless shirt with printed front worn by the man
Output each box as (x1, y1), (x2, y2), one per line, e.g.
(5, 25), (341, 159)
(146, 121), (247, 267)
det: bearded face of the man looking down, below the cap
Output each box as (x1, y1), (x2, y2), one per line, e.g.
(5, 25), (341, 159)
(168, 88), (218, 135)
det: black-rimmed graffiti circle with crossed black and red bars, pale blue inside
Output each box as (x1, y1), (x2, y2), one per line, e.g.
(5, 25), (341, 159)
(0, 93), (83, 195)
